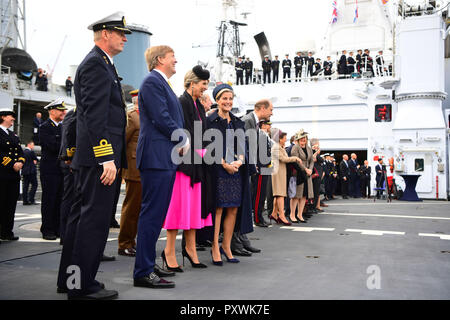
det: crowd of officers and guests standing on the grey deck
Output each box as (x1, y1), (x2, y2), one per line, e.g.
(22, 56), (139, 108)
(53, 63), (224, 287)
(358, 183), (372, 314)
(0, 14), (388, 300)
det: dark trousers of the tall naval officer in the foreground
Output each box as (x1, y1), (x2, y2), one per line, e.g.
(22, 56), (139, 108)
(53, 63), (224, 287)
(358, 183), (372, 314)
(58, 166), (118, 296)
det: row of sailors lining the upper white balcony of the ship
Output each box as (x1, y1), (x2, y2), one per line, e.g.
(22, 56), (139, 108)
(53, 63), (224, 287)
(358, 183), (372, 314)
(235, 49), (392, 85)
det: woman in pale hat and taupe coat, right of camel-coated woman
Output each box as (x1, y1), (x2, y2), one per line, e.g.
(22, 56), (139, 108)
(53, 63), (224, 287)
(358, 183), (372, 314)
(290, 129), (314, 223)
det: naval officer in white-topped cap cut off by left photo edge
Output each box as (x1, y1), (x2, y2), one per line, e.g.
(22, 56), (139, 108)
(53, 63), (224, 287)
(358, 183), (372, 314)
(0, 109), (25, 243)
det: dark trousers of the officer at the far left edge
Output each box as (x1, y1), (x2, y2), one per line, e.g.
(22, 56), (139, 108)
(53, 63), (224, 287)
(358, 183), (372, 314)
(0, 176), (20, 238)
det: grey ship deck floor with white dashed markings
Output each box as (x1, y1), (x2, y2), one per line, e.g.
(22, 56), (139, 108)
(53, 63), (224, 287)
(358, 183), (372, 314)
(0, 195), (450, 301)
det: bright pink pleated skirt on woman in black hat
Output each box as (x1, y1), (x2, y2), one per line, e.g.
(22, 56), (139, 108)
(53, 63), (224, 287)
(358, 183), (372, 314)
(163, 150), (213, 230)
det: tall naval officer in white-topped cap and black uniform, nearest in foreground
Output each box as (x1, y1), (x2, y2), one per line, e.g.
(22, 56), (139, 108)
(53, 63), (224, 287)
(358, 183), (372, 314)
(59, 12), (131, 300)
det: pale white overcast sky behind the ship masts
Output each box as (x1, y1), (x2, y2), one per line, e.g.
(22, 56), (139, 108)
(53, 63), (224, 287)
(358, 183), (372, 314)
(26, 0), (432, 91)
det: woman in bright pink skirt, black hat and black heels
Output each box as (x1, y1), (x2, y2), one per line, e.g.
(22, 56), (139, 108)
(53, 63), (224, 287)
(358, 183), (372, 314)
(161, 66), (212, 272)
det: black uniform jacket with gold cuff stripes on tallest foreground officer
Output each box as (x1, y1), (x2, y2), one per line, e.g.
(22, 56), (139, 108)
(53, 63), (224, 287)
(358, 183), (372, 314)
(72, 46), (127, 168)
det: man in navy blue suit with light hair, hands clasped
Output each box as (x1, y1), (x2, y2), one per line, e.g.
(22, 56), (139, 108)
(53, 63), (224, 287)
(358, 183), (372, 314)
(133, 46), (190, 288)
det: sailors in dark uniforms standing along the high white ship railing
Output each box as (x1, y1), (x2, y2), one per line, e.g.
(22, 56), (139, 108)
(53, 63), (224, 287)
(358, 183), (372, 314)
(235, 49), (388, 85)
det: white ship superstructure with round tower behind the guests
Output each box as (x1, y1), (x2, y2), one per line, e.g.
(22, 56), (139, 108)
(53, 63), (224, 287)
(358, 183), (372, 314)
(216, 0), (449, 199)
